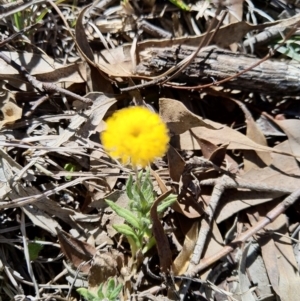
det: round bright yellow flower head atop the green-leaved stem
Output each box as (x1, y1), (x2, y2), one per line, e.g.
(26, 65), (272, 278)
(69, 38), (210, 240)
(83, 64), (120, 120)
(101, 107), (170, 167)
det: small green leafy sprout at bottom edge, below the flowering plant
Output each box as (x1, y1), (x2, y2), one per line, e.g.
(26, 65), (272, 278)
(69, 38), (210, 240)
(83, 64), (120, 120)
(77, 278), (123, 301)
